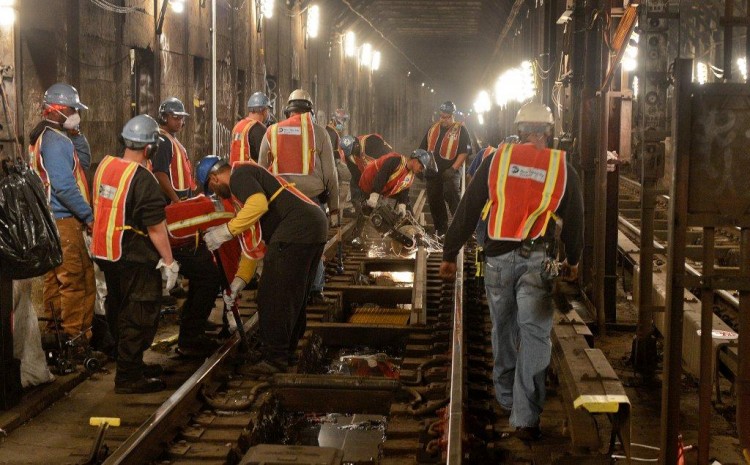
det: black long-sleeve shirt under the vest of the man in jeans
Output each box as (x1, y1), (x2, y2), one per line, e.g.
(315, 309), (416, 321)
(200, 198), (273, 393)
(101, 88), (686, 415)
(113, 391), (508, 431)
(443, 149), (583, 265)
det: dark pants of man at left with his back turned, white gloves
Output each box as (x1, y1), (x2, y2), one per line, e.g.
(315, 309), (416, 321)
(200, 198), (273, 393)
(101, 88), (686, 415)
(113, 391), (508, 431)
(99, 260), (161, 383)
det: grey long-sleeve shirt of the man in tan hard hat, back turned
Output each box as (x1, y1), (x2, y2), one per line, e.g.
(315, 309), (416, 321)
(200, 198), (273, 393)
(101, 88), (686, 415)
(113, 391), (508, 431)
(258, 118), (339, 210)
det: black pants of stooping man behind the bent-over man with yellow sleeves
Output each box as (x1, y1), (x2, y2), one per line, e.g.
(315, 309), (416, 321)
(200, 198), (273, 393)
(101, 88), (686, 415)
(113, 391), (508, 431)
(172, 243), (223, 343)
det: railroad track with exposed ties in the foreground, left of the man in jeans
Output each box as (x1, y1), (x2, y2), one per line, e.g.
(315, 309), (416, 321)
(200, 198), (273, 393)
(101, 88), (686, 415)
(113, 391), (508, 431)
(98, 208), (476, 464)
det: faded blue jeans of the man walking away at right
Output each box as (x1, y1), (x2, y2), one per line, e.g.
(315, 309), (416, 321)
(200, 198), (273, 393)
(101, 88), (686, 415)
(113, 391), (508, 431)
(484, 245), (553, 427)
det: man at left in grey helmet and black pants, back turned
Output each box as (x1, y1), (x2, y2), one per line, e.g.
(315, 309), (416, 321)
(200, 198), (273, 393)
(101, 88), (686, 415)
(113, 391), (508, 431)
(91, 115), (180, 394)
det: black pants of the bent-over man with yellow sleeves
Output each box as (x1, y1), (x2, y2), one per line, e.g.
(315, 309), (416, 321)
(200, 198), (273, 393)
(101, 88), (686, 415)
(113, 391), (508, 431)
(257, 242), (324, 366)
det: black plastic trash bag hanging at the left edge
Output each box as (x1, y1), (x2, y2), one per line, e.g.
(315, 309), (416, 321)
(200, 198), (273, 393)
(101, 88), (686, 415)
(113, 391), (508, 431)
(0, 160), (62, 279)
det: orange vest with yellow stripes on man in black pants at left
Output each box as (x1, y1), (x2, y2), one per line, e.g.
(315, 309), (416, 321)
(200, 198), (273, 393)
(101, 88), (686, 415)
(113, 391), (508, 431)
(91, 155), (138, 262)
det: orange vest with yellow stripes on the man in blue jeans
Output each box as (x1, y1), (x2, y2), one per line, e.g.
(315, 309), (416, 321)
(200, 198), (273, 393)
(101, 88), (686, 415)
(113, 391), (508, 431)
(483, 144), (567, 241)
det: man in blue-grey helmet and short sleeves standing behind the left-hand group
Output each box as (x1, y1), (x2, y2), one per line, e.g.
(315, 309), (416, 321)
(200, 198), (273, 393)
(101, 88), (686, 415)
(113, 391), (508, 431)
(151, 97), (196, 203)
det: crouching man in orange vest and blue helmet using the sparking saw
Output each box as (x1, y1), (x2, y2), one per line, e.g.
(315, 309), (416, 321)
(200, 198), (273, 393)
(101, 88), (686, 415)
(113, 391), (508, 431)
(359, 149), (437, 216)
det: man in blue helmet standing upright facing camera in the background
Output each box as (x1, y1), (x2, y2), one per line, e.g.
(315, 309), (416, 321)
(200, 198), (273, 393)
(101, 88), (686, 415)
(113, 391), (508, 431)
(419, 101), (471, 236)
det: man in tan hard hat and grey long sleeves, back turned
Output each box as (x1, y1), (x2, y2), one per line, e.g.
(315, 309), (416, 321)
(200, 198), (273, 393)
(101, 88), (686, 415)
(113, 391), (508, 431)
(259, 89), (339, 304)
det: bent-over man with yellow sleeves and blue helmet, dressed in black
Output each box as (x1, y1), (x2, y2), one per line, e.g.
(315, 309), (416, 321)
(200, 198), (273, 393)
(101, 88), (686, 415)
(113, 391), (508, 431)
(198, 157), (328, 374)
